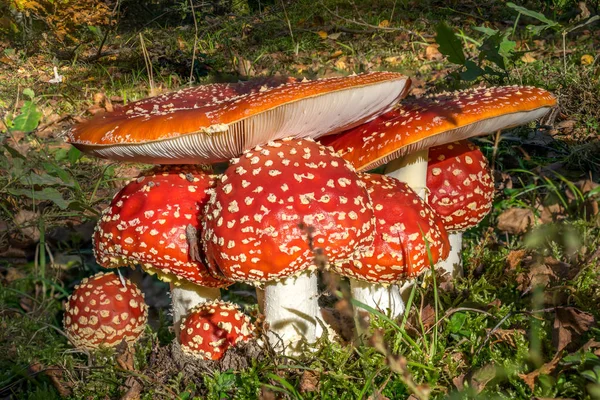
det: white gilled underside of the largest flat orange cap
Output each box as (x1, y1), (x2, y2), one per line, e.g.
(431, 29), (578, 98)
(82, 79), (406, 164)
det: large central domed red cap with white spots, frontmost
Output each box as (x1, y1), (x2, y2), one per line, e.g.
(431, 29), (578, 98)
(203, 139), (374, 284)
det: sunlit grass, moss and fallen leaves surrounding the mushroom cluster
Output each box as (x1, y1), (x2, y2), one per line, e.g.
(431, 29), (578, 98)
(0, 0), (600, 400)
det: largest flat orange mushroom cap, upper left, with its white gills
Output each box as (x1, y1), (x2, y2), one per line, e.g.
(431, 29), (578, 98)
(66, 72), (409, 164)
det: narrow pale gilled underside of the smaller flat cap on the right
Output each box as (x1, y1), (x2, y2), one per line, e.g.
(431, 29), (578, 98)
(368, 107), (550, 171)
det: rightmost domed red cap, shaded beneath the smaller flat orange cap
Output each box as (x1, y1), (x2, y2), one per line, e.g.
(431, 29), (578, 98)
(427, 140), (494, 232)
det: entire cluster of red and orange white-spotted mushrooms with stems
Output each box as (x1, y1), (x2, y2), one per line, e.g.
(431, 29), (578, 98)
(65, 72), (556, 359)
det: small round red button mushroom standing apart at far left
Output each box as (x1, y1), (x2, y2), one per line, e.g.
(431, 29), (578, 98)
(64, 272), (148, 349)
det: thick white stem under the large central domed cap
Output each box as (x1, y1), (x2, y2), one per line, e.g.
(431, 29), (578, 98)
(257, 272), (323, 354)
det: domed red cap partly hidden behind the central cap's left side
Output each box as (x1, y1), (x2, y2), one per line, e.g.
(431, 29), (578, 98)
(93, 166), (230, 287)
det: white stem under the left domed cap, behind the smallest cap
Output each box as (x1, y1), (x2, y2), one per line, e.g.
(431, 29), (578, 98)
(171, 282), (221, 336)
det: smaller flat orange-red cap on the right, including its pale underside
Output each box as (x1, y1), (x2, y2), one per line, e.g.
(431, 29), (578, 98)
(320, 86), (556, 171)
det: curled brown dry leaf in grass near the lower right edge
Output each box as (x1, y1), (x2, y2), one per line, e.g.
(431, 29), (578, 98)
(552, 307), (596, 351)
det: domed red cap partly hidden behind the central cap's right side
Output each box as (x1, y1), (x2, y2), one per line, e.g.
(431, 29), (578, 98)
(333, 173), (450, 283)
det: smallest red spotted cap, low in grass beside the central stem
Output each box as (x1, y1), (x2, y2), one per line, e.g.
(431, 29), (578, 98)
(179, 301), (254, 360)
